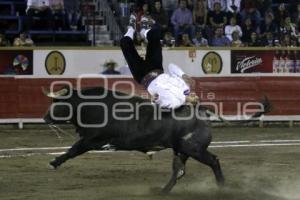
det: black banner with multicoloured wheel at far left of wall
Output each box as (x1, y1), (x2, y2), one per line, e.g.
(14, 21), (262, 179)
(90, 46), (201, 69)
(0, 50), (33, 75)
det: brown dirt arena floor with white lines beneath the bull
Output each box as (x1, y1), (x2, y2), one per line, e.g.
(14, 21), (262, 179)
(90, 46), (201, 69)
(0, 125), (300, 200)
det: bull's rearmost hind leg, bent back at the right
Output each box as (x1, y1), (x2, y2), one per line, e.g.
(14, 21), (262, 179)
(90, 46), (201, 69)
(192, 150), (225, 186)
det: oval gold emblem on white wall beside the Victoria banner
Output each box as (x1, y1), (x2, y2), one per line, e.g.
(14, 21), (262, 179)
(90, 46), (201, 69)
(202, 51), (223, 74)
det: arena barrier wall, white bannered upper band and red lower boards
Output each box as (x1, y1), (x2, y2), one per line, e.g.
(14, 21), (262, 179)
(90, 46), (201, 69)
(0, 48), (300, 123)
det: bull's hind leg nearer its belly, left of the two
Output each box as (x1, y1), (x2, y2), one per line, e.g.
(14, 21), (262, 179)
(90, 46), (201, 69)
(162, 154), (188, 193)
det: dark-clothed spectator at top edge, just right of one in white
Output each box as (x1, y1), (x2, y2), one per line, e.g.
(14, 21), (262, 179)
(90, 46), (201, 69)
(240, 0), (261, 28)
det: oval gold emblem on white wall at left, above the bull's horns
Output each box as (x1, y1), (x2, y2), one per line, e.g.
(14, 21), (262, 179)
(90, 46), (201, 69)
(45, 51), (66, 75)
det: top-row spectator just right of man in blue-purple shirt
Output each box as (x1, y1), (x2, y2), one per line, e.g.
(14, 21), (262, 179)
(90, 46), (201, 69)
(193, 0), (208, 30)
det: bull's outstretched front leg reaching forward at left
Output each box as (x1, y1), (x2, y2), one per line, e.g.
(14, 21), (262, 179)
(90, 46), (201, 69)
(50, 139), (91, 169)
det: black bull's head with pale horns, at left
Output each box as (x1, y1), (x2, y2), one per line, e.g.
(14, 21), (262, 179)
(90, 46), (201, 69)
(42, 88), (73, 124)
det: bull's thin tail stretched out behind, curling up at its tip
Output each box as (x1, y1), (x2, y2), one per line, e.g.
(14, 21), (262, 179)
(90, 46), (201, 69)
(202, 96), (272, 125)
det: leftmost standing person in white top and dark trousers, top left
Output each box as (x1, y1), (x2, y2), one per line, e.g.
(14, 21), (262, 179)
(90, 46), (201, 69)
(26, 0), (52, 29)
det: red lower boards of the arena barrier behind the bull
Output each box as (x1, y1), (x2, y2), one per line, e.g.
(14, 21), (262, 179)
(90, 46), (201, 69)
(0, 77), (300, 123)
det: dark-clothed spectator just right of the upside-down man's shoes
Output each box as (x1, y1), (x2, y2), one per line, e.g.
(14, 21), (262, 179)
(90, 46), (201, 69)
(151, 0), (169, 35)
